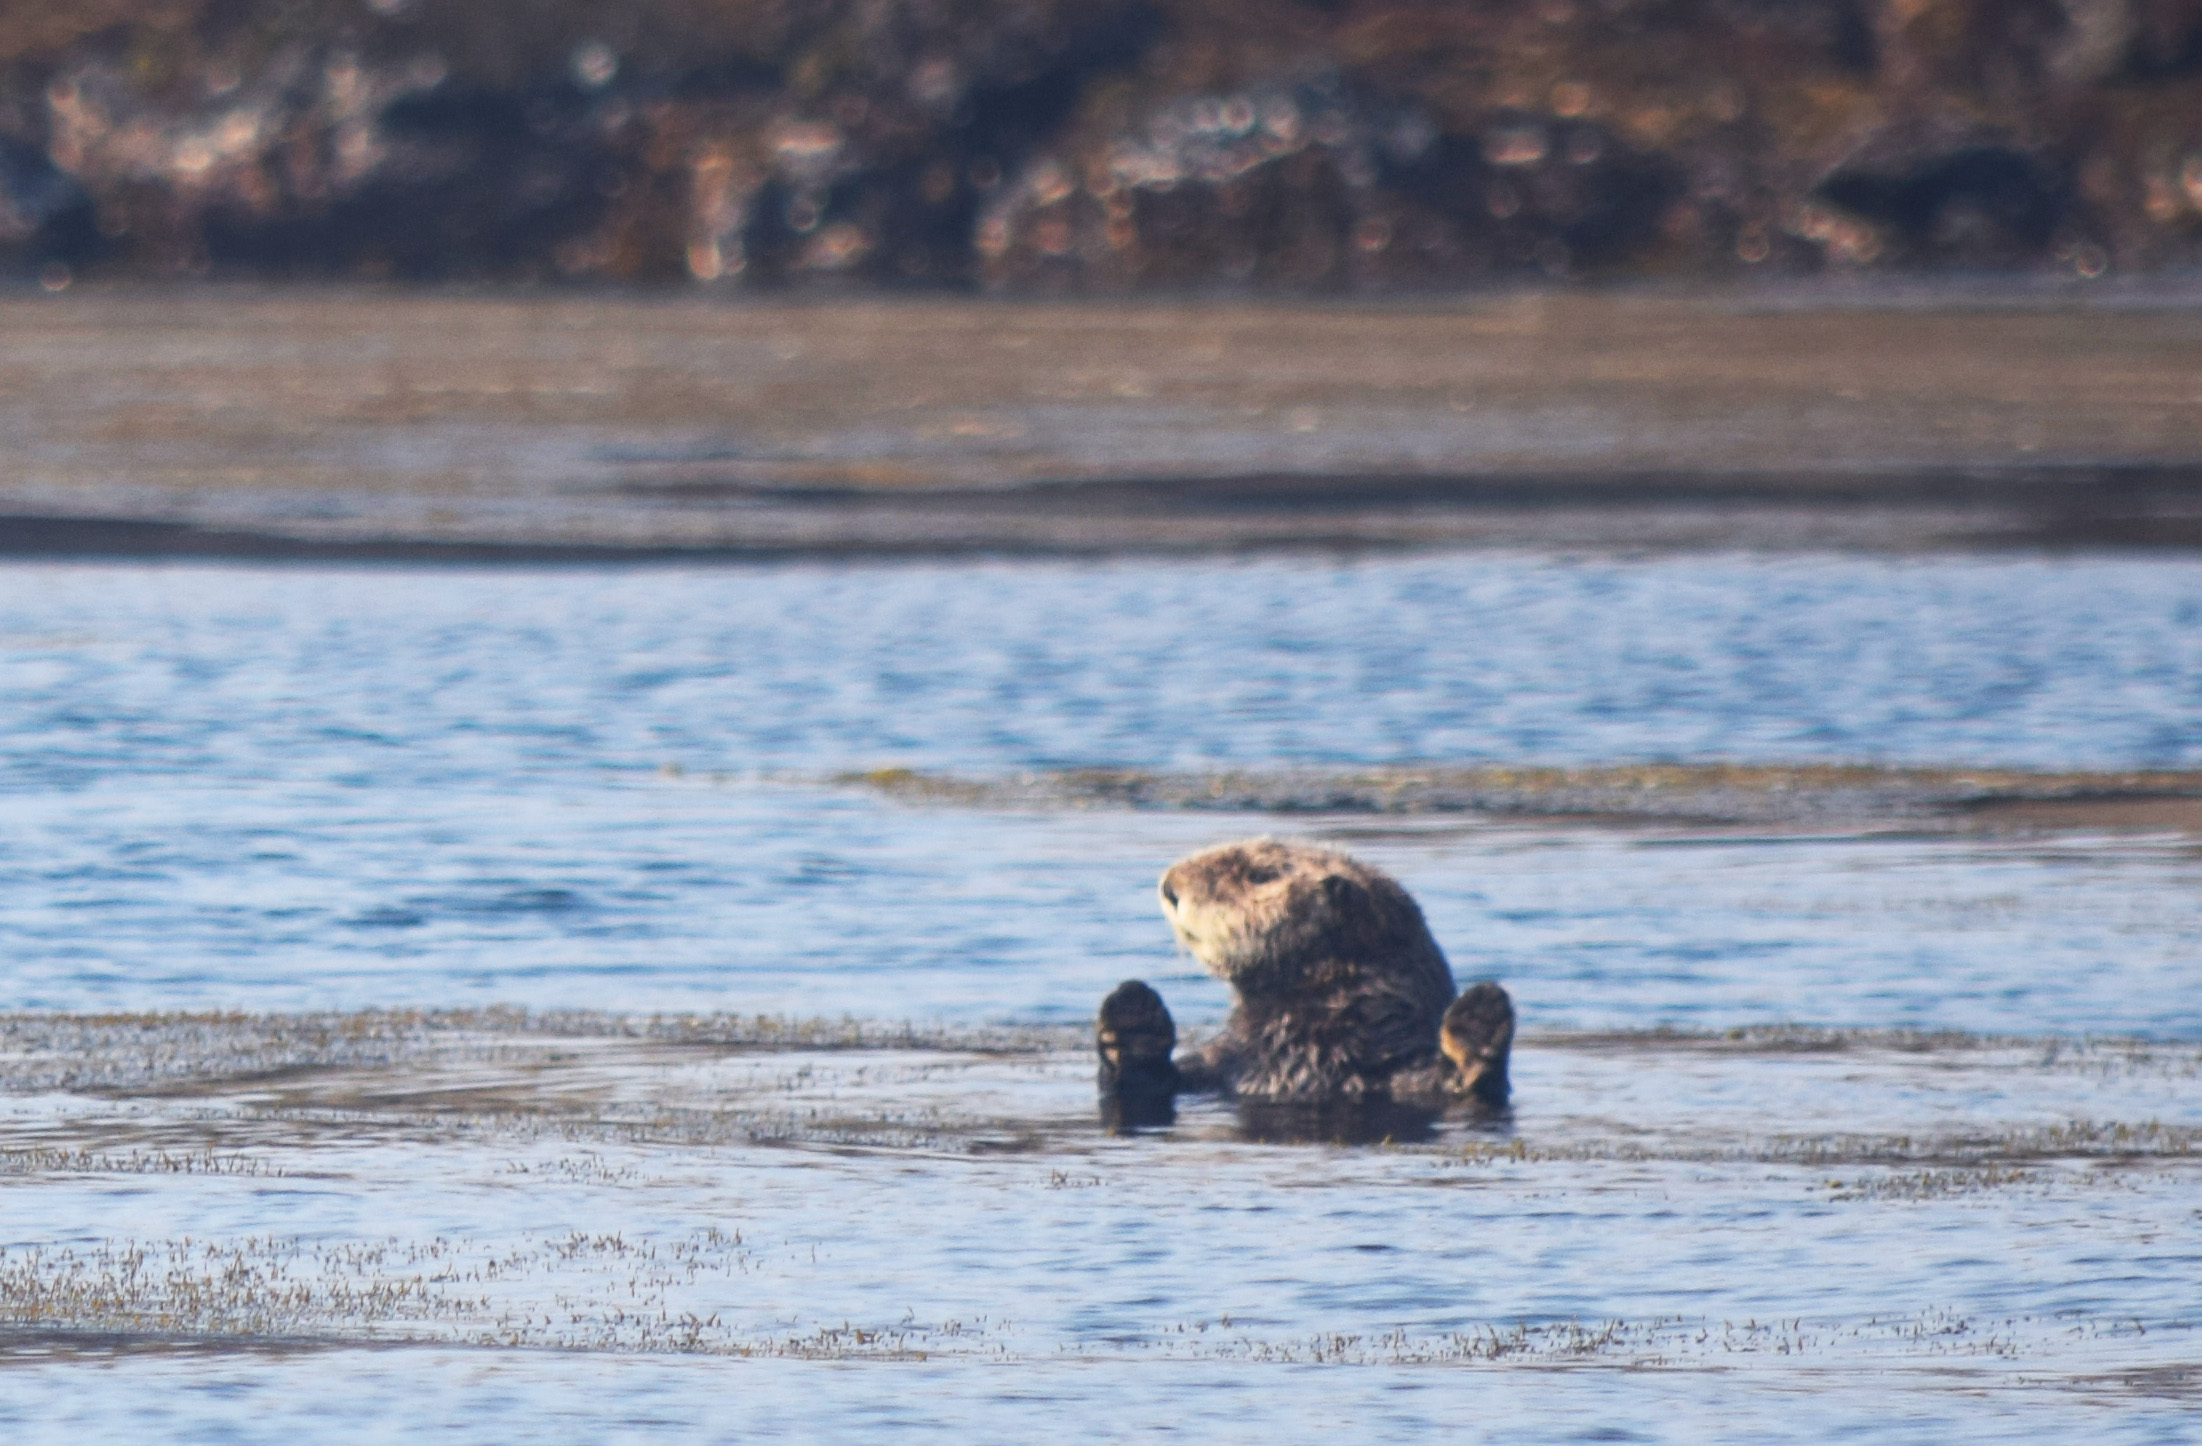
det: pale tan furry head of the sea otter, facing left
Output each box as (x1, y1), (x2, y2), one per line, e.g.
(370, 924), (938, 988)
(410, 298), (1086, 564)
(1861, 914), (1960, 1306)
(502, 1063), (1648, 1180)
(1156, 839), (1409, 995)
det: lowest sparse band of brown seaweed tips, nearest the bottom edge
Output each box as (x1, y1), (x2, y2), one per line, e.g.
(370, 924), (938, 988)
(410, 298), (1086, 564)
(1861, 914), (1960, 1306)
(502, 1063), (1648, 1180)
(0, 1226), (2113, 1355)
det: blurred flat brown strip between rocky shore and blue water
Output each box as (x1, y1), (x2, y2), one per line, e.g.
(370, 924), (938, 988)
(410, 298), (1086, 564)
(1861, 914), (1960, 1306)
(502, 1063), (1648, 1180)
(0, 286), (2202, 561)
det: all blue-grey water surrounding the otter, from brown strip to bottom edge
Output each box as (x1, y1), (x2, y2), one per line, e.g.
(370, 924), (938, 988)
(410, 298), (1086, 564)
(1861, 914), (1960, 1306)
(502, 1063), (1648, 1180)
(0, 555), (2202, 1442)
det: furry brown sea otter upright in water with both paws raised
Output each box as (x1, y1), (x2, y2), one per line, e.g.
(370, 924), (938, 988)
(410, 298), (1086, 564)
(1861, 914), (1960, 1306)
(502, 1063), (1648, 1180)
(1094, 839), (1513, 1107)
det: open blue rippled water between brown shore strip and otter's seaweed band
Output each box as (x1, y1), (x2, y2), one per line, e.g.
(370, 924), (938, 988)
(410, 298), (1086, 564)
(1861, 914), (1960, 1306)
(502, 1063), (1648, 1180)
(0, 557), (2202, 1016)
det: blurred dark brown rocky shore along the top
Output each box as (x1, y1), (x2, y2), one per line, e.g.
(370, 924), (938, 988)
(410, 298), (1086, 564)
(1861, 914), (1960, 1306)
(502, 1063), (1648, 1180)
(0, 0), (2202, 295)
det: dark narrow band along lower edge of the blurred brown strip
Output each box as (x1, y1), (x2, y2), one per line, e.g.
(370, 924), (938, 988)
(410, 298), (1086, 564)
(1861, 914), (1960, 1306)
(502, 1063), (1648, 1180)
(0, 464), (2202, 566)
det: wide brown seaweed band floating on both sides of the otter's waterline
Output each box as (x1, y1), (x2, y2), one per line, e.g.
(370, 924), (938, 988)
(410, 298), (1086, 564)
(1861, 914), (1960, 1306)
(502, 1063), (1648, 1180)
(0, 1010), (2202, 1170)
